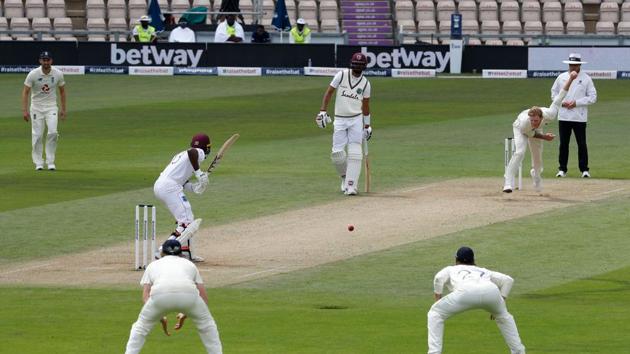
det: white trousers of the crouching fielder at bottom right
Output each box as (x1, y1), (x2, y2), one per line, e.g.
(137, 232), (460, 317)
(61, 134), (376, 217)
(427, 282), (525, 354)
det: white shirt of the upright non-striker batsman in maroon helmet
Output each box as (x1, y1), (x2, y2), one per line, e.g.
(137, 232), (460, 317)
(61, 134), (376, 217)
(330, 69), (371, 118)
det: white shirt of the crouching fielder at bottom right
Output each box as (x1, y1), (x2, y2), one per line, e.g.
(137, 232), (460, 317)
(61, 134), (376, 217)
(433, 264), (514, 298)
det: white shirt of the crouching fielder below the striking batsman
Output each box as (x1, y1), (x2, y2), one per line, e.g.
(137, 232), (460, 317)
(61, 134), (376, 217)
(140, 256), (203, 295)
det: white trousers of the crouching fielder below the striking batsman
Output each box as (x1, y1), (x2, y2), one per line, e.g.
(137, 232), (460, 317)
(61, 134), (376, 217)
(125, 289), (223, 354)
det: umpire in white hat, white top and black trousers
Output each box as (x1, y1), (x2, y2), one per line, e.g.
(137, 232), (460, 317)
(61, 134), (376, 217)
(551, 53), (597, 178)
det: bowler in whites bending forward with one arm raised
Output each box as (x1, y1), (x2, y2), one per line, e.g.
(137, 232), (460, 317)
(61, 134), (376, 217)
(503, 71), (577, 193)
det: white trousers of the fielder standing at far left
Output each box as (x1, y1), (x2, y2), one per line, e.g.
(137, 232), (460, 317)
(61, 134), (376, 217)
(31, 108), (59, 166)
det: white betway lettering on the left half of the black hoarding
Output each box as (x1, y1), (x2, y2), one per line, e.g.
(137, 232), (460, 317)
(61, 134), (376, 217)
(110, 43), (203, 67)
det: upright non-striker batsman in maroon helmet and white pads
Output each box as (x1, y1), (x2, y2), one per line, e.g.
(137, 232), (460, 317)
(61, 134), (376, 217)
(315, 53), (372, 195)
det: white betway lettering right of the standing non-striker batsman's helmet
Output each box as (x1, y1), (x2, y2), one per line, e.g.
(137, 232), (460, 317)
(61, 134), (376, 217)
(361, 47), (450, 73)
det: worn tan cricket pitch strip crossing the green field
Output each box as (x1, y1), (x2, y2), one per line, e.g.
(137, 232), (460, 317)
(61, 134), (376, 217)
(0, 178), (630, 287)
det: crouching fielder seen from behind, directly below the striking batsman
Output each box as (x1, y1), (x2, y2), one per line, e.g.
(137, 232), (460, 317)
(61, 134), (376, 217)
(125, 240), (222, 354)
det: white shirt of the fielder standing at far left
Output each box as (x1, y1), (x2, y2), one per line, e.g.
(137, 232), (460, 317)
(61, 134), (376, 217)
(24, 66), (66, 111)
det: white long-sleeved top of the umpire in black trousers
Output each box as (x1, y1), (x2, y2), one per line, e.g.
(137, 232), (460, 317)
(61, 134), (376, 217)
(551, 71), (597, 122)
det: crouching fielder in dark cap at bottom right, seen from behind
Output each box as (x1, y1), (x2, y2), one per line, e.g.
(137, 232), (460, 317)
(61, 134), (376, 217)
(427, 247), (525, 354)
